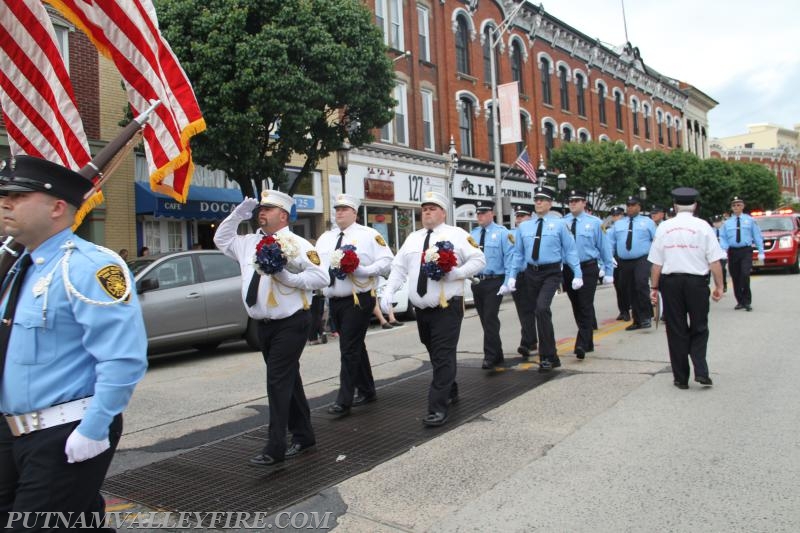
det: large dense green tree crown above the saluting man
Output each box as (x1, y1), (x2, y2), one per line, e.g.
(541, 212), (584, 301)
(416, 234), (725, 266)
(157, 0), (395, 197)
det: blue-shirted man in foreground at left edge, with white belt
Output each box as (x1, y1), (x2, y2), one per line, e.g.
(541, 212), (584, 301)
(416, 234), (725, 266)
(0, 156), (147, 531)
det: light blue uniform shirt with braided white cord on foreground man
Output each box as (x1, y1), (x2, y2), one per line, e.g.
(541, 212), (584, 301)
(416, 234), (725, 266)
(0, 229), (147, 440)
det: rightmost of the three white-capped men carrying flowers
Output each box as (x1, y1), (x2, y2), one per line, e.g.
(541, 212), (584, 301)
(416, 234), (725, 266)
(381, 191), (486, 426)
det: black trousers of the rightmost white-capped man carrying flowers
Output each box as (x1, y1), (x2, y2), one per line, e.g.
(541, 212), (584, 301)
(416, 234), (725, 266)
(416, 296), (464, 413)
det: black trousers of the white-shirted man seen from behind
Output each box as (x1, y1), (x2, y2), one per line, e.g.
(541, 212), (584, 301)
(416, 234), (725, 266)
(658, 274), (711, 383)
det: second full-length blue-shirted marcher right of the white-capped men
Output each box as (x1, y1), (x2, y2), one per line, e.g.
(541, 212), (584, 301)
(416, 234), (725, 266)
(515, 186), (583, 372)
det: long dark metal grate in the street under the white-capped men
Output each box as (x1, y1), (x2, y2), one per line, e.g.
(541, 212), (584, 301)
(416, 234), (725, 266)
(103, 366), (559, 513)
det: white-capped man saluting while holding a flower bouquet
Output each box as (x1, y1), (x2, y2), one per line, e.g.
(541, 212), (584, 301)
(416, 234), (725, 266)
(214, 190), (328, 466)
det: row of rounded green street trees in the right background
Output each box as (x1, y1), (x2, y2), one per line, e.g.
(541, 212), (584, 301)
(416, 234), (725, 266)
(549, 142), (781, 218)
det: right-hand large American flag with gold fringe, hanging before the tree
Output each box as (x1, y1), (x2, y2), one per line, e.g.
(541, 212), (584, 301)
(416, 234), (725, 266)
(45, 0), (206, 202)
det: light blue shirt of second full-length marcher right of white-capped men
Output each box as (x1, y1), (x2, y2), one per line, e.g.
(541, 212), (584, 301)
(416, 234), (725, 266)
(515, 215), (583, 279)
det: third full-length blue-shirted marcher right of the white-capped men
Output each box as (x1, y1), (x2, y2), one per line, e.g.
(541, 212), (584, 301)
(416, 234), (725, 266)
(563, 190), (614, 359)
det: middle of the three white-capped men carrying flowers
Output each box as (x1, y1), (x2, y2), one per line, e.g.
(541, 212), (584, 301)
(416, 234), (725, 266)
(317, 194), (394, 416)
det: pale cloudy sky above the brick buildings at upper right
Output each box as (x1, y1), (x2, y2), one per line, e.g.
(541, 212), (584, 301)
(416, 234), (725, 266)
(544, 0), (800, 138)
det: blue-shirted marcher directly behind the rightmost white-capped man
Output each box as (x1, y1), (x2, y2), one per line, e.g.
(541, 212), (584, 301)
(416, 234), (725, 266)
(471, 201), (516, 369)
